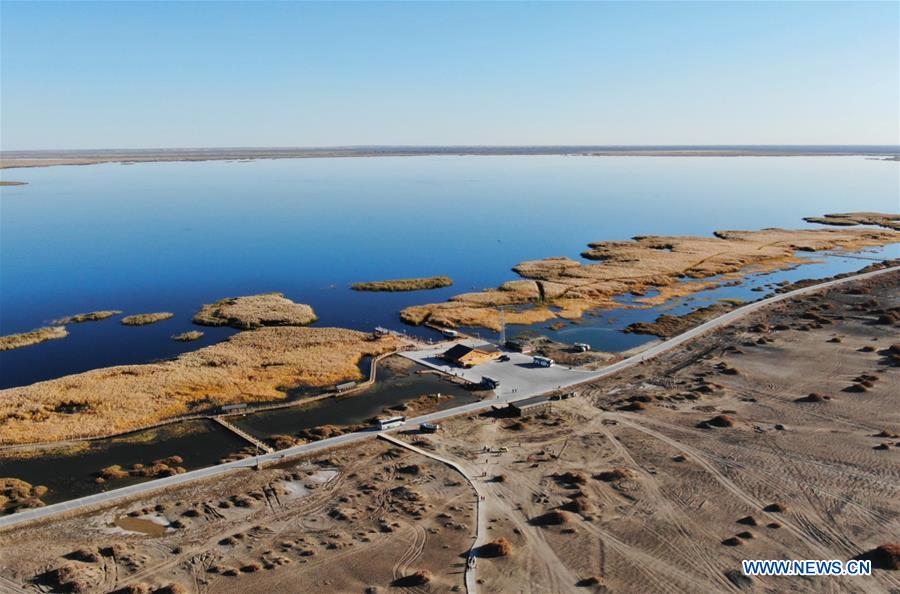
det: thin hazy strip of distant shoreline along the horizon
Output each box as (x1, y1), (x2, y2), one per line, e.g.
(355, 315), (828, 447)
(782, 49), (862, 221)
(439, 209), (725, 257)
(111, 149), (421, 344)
(0, 145), (900, 169)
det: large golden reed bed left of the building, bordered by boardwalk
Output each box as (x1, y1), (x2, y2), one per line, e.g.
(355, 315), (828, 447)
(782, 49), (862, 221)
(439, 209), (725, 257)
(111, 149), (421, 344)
(0, 327), (397, 444)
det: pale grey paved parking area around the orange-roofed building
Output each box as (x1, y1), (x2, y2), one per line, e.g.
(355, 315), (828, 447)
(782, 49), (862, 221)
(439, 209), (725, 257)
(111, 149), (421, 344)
(400, 340), (600, 399)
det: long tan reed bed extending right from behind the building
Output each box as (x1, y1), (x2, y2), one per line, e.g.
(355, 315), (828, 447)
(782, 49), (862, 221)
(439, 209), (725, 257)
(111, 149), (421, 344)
(400, 222), (900, 331)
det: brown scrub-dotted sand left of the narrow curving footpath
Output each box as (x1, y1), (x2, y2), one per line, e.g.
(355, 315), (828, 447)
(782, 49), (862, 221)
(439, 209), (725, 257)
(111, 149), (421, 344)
(0, 441), (475, 594)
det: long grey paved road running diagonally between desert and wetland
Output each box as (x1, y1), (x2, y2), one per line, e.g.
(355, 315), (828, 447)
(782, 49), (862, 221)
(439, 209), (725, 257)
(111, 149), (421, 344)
(0, 266), (900, 531)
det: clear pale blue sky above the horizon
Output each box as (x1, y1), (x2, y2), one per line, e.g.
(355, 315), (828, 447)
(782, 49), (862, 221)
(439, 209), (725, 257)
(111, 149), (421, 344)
(0, 0), (900, 150)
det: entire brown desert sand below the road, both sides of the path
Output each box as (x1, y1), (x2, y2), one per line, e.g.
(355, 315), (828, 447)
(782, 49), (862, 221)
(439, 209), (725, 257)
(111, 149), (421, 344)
(0, 274), (900, 593)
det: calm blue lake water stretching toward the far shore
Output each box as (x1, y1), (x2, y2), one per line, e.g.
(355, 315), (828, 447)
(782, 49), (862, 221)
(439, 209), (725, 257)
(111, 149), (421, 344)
(0, 156), (900, 387)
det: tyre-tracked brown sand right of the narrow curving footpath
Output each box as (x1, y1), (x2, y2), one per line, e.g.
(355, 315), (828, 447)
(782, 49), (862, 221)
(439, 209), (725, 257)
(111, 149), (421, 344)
(416, 275), (900, 592)
